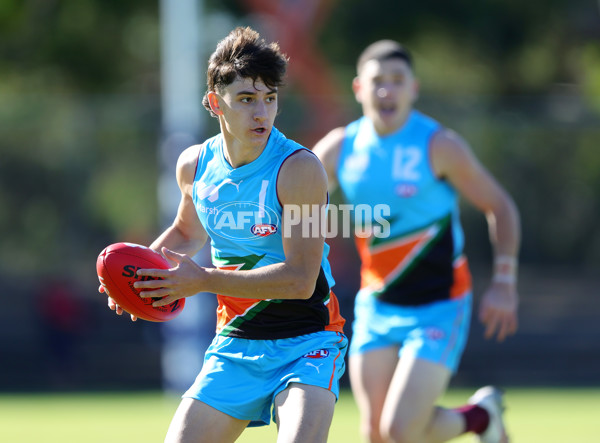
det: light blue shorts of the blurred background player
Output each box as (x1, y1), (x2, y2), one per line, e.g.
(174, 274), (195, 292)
(350, 292), (472, 373)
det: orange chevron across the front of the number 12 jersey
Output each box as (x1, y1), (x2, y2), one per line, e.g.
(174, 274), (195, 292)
(356, 224), (441, 292)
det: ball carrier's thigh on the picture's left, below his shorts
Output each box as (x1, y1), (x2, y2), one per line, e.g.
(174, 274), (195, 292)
(165, 398), (249, 443)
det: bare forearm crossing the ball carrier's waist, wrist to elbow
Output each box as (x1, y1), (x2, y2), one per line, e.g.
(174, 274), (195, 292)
(202, 262), (318, 300)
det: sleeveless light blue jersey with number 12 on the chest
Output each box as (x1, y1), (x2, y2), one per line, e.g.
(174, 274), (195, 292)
(337, 111), (464, 304)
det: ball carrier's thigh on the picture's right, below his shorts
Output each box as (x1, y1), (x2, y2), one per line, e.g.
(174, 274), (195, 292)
(275, 383), (335, 443)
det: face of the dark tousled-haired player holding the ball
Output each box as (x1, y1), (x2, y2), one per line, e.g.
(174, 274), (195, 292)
(212, 78), (277, 149)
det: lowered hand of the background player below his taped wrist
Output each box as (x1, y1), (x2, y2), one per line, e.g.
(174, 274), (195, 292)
(479, 282), (519, 342)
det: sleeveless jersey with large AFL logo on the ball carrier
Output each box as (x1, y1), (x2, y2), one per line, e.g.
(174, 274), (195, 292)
(192, 128), (342, 339)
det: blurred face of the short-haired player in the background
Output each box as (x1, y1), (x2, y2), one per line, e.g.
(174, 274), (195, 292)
(353, 58), (418, 135)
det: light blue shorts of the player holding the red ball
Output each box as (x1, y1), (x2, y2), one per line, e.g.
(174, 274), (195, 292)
(183, 331), (348, 426)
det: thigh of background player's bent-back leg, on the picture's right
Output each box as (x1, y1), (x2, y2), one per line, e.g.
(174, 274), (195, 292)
(381, 355), (452, 434)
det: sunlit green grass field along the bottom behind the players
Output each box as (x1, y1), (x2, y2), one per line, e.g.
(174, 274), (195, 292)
(0, 388), (600, 443)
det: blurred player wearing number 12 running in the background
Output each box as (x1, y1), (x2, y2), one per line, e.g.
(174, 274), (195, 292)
(314, 40), (520, 443)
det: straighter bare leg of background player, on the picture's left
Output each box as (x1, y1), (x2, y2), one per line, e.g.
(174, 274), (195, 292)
(349, 346), (398, 443)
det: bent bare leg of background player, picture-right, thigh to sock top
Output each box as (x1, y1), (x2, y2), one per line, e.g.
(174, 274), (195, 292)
(381, 357), (465, 443)
